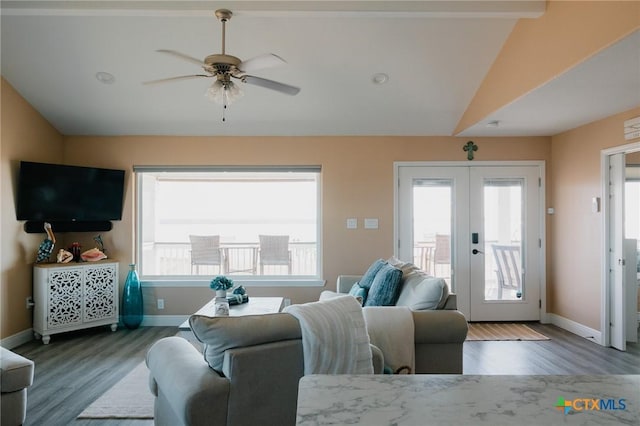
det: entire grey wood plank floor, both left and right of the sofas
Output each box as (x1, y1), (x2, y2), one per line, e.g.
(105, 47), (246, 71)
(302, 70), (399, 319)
(13, 324), (640, 426)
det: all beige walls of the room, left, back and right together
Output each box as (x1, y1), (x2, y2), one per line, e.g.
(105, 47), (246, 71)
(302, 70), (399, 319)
(0, 77), (640, 338)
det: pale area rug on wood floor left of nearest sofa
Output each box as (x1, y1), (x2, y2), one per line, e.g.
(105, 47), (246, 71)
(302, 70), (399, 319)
(78, 362), (153, 419)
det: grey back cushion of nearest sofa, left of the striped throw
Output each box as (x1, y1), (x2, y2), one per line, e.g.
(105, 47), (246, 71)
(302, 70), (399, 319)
(189, 313), (302, 373)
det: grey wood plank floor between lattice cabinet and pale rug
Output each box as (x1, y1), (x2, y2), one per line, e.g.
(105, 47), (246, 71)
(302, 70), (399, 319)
(13, 327), (178, 426)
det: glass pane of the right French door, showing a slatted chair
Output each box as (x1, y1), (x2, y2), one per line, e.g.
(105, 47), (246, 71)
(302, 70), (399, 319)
(484, 178), (524, 300)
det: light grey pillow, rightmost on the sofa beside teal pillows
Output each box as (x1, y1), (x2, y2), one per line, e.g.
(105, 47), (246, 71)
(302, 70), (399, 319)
(396, 272), (449, 311)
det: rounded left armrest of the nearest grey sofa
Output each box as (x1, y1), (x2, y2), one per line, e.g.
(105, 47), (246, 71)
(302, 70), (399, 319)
(146, 336), (229, 425)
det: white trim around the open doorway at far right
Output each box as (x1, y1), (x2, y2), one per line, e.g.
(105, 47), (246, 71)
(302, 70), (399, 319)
(598, 142), (640, 346)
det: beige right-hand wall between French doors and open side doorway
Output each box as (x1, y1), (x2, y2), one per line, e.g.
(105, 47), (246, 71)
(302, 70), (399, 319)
(547, 108), (640, 330)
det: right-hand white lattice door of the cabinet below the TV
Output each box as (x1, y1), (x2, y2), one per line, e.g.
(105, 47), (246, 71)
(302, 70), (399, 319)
(83, 264), (118, 322)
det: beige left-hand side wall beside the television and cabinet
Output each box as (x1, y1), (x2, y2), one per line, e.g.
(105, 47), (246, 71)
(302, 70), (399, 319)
(0, 78), (63, 338)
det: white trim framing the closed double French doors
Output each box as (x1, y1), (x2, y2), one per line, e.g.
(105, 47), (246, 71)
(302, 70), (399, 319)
(393, 161), (548, 323)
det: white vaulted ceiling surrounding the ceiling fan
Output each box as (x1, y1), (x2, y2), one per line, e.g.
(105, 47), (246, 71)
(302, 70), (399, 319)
(0, 0), (640, 136)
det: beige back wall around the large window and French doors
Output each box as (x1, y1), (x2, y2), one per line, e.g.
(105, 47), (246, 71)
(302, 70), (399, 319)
(57, 136), (550, 315)
